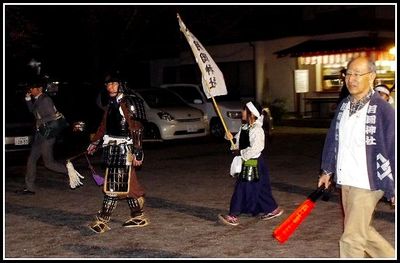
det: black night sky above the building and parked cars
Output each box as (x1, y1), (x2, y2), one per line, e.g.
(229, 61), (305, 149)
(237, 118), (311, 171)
(5, 4), (394, 85)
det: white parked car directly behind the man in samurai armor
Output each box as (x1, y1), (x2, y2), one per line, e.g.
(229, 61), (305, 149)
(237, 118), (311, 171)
(132, 88), (207, 141)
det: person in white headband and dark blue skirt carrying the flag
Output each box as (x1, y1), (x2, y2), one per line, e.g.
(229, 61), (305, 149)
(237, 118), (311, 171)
(218, 101), (283, 226)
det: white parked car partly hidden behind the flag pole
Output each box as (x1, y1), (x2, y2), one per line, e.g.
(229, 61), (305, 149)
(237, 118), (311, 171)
(160, 84), (243, 137)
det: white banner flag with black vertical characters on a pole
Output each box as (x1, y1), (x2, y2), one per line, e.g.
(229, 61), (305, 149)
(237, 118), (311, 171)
(177, 14), (228, 99)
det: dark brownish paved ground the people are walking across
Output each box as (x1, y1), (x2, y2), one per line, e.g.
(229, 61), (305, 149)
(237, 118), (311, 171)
(3, 127), (396, 259)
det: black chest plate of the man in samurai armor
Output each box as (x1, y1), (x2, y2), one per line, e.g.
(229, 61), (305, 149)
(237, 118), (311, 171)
(106, 99), (129, 137)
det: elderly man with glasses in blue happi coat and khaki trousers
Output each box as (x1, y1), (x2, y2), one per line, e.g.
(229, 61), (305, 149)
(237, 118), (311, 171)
(318, 57), (396, 258)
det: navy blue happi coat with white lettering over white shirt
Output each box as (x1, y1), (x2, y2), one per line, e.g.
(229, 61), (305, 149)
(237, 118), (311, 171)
(321, 92), (396, 199)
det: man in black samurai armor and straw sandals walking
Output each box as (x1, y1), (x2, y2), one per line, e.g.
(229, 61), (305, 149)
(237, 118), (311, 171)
(87, 75), (149, 233)
